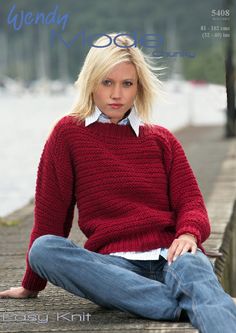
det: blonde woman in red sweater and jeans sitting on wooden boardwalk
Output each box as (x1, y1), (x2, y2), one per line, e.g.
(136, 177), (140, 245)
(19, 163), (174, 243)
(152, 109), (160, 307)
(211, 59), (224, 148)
(0, 34), (236, 333)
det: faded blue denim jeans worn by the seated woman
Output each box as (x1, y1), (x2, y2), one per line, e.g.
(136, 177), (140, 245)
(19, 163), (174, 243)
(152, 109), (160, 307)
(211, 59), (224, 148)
(29, 235), (236, 333)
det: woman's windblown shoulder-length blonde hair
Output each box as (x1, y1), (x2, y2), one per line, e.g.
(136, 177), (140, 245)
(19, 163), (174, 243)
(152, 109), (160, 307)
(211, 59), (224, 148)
(70, 33), (162, 123)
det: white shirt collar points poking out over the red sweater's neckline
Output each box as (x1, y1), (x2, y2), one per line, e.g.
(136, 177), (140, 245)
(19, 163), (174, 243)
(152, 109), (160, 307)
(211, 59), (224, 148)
(85, 106), (142, 136)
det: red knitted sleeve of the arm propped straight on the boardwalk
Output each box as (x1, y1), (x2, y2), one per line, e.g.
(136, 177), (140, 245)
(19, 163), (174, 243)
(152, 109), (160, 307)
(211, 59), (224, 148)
(22, 121), (76, 291)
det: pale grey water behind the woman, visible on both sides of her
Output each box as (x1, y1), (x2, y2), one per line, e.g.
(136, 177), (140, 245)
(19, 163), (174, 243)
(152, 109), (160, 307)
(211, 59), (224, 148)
(0, 81), (226, 216)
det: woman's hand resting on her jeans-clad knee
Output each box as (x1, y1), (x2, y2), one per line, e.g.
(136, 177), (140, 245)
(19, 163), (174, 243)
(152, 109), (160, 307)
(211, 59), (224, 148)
(167, 234), (197, 265)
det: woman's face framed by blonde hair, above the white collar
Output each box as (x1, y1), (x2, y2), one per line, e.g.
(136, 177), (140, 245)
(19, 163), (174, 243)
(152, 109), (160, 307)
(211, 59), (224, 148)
(93, 62), (138, 124)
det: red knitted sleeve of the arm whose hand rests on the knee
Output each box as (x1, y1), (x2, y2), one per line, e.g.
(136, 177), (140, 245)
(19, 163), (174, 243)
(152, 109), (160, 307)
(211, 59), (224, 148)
(169, 136), (210, 247)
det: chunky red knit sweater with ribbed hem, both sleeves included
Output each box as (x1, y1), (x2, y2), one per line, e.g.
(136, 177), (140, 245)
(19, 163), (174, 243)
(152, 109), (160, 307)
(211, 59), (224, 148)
(22, 115), (210, 290)
